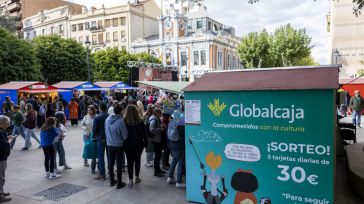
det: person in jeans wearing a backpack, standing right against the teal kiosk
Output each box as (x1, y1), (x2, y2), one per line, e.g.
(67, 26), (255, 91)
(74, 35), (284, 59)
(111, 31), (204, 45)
(167, 111), (186, 188)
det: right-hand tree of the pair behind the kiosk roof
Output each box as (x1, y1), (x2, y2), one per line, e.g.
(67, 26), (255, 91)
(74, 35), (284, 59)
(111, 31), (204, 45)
(269, 24), (312, 67)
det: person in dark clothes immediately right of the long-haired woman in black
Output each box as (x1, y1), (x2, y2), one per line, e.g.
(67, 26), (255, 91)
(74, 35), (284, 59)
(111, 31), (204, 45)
(149, 108), (165, 177)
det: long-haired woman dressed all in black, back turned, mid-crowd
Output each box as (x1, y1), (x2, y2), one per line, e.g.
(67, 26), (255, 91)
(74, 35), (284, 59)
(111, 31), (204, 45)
(124, 105), (148, 186)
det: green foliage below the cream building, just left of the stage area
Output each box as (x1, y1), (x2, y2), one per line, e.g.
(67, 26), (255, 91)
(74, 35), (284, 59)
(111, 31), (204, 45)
(93, 48), (160, 82)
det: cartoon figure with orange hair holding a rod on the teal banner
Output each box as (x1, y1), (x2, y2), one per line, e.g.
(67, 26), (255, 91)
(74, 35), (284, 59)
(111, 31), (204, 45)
(201, 152), (228, 204)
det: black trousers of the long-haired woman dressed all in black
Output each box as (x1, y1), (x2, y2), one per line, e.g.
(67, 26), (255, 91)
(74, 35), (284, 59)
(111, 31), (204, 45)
(125, 148), (143, 181)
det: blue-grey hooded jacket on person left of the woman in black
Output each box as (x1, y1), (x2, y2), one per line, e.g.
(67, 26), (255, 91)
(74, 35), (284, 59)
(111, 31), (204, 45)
(105, 115), (128, 147)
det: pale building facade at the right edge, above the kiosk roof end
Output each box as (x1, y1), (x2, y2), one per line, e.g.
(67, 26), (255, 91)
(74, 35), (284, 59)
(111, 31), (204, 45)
(327, 0), (364, 78)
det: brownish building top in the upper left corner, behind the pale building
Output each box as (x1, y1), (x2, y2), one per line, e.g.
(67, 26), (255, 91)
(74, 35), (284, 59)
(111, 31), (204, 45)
(0, 0), (82, 33)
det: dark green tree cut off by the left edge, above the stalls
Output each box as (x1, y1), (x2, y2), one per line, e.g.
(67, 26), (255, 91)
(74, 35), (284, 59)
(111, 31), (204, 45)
(0, 28), (41, 83)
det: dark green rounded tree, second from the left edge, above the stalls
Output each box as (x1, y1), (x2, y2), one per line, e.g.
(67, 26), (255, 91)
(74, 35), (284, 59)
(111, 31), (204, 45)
(32, 35), (88, 84)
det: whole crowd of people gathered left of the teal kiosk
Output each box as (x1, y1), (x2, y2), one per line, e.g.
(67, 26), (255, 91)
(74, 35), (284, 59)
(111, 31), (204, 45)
(0, 92), (185, 202)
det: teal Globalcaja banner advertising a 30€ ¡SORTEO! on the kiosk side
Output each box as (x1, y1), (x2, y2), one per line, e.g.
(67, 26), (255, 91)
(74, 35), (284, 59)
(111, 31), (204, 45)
(185, 90), (335, 204)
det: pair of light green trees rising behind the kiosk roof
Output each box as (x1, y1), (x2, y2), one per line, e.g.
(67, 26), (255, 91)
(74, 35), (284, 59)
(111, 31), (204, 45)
(238, 24), (315, 68)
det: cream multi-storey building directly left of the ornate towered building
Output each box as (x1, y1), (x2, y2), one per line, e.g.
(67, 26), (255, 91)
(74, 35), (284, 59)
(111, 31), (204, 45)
(69, 0), (161, 51)
